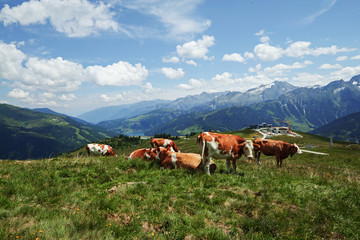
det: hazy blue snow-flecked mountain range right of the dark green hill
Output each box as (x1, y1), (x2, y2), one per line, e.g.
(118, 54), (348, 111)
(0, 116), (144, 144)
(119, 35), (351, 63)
(90, 75), (360, 135)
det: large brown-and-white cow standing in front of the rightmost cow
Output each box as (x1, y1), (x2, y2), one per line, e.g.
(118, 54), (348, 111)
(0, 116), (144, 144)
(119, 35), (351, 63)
(197, 132), (253, 175)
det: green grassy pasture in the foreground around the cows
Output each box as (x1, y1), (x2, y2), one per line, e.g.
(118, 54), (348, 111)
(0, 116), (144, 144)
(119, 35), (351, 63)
(0, 131), (360, 239)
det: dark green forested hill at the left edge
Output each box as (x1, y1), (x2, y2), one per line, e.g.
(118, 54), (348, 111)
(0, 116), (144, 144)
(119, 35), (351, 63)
(0, 104), (114, 160)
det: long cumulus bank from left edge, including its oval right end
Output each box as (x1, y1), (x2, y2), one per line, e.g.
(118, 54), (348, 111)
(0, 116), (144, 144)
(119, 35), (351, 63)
(0, 42), (148, 96)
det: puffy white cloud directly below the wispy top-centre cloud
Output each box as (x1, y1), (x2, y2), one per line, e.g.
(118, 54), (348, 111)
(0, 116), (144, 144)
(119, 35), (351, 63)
(176, 35), (215, 59)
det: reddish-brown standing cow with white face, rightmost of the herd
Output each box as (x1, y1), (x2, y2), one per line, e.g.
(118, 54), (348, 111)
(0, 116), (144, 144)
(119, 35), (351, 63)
(253, 138), (302, 167)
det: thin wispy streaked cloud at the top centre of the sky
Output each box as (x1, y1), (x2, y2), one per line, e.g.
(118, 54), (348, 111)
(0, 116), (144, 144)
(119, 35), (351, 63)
(117, 0), (211, 39)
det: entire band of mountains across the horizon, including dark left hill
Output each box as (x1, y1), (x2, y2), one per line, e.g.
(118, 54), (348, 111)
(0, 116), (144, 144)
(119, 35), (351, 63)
(0, 75), (360, 159)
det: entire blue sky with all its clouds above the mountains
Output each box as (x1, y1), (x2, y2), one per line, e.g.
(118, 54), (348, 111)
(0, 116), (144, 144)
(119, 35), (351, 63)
(0, 0), (360, 116)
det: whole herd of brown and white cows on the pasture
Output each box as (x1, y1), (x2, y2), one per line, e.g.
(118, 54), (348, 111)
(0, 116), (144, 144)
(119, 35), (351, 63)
(86, 132), (302, 175)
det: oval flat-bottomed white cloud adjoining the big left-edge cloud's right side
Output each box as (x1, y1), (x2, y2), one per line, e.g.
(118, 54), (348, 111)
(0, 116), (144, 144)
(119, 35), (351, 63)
(85, 61), (148, 86)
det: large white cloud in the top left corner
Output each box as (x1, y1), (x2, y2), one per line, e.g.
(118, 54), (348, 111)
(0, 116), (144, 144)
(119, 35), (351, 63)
(0, 0), (121, 37)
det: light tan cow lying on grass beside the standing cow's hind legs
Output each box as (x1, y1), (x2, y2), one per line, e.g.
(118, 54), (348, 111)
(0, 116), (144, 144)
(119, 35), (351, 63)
(159, 150), (216, 173)
